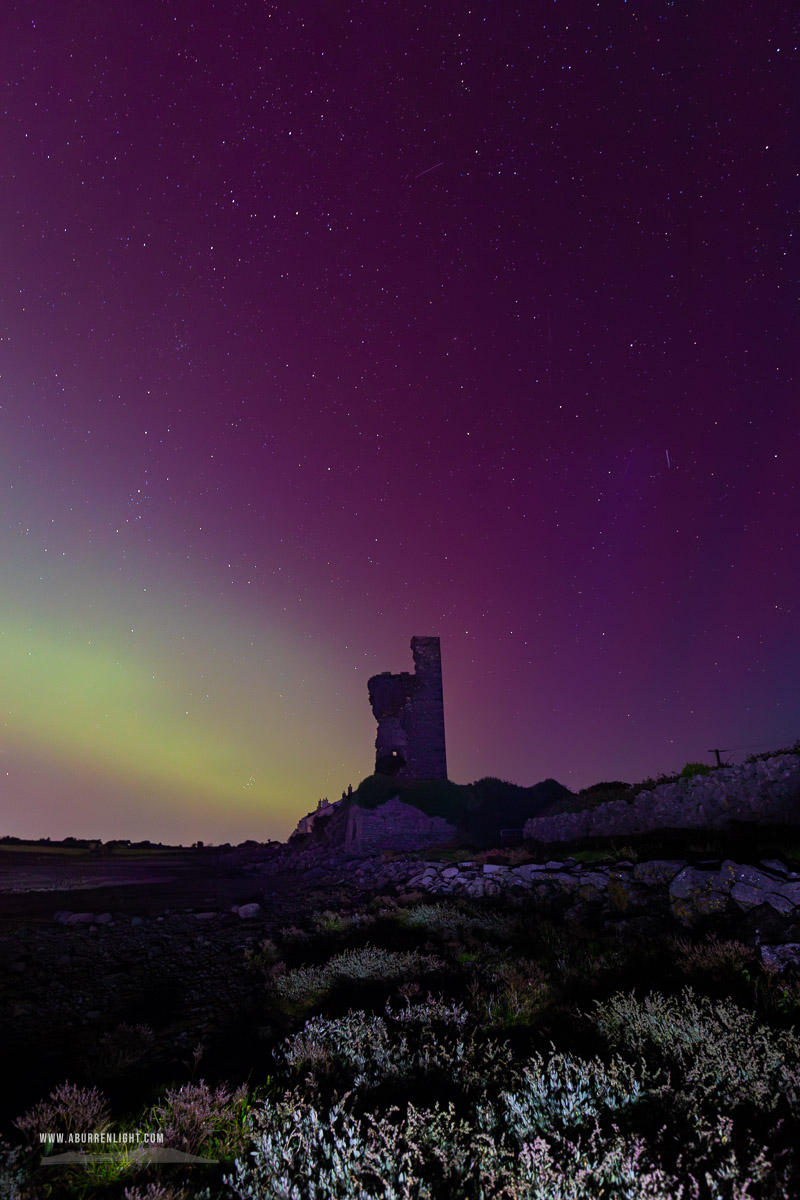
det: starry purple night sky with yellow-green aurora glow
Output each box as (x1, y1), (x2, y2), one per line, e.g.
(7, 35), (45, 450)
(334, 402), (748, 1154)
(0, 0), (800, 844)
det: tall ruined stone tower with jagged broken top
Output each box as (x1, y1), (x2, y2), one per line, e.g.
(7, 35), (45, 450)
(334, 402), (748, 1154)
(367, 637), (447, 779)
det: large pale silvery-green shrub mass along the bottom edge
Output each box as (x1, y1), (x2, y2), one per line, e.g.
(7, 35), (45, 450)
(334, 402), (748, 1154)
(224, 1093), (788, 1200)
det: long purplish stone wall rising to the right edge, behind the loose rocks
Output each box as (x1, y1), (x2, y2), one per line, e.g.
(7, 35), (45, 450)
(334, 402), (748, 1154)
(524, 754), (800, 845)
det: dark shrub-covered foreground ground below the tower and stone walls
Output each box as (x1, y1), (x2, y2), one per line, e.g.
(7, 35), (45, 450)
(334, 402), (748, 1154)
(0, 830), (800, 1200)
